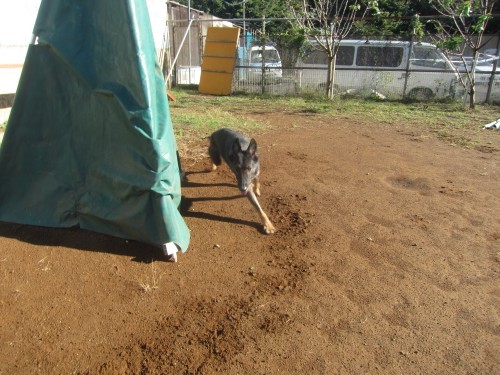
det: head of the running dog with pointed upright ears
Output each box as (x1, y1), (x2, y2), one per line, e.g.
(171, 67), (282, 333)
(230, 138), (260, 195)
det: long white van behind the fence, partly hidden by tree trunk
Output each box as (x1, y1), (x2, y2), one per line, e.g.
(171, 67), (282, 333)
(296, 39), (457, 99)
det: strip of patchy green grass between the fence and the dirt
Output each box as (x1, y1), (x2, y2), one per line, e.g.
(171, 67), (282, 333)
(170, 89), (500, 156)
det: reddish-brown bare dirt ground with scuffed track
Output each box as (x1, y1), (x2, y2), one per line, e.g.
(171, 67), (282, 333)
(0, 107), (500, 374)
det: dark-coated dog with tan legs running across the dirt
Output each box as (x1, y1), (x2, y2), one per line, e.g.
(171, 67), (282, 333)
(208, 128), (276, 234)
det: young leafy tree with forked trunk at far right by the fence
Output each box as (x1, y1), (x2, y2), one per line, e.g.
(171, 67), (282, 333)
(431, 0), (497, 109)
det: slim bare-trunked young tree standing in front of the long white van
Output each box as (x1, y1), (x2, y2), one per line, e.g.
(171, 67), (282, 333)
(287, 0), (378, 99)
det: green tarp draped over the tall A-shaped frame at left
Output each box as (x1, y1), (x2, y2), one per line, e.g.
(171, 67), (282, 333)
(0, 0), (189, 251)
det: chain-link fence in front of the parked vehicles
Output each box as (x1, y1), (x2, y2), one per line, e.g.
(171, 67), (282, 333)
(168, 15), (500, 103)
